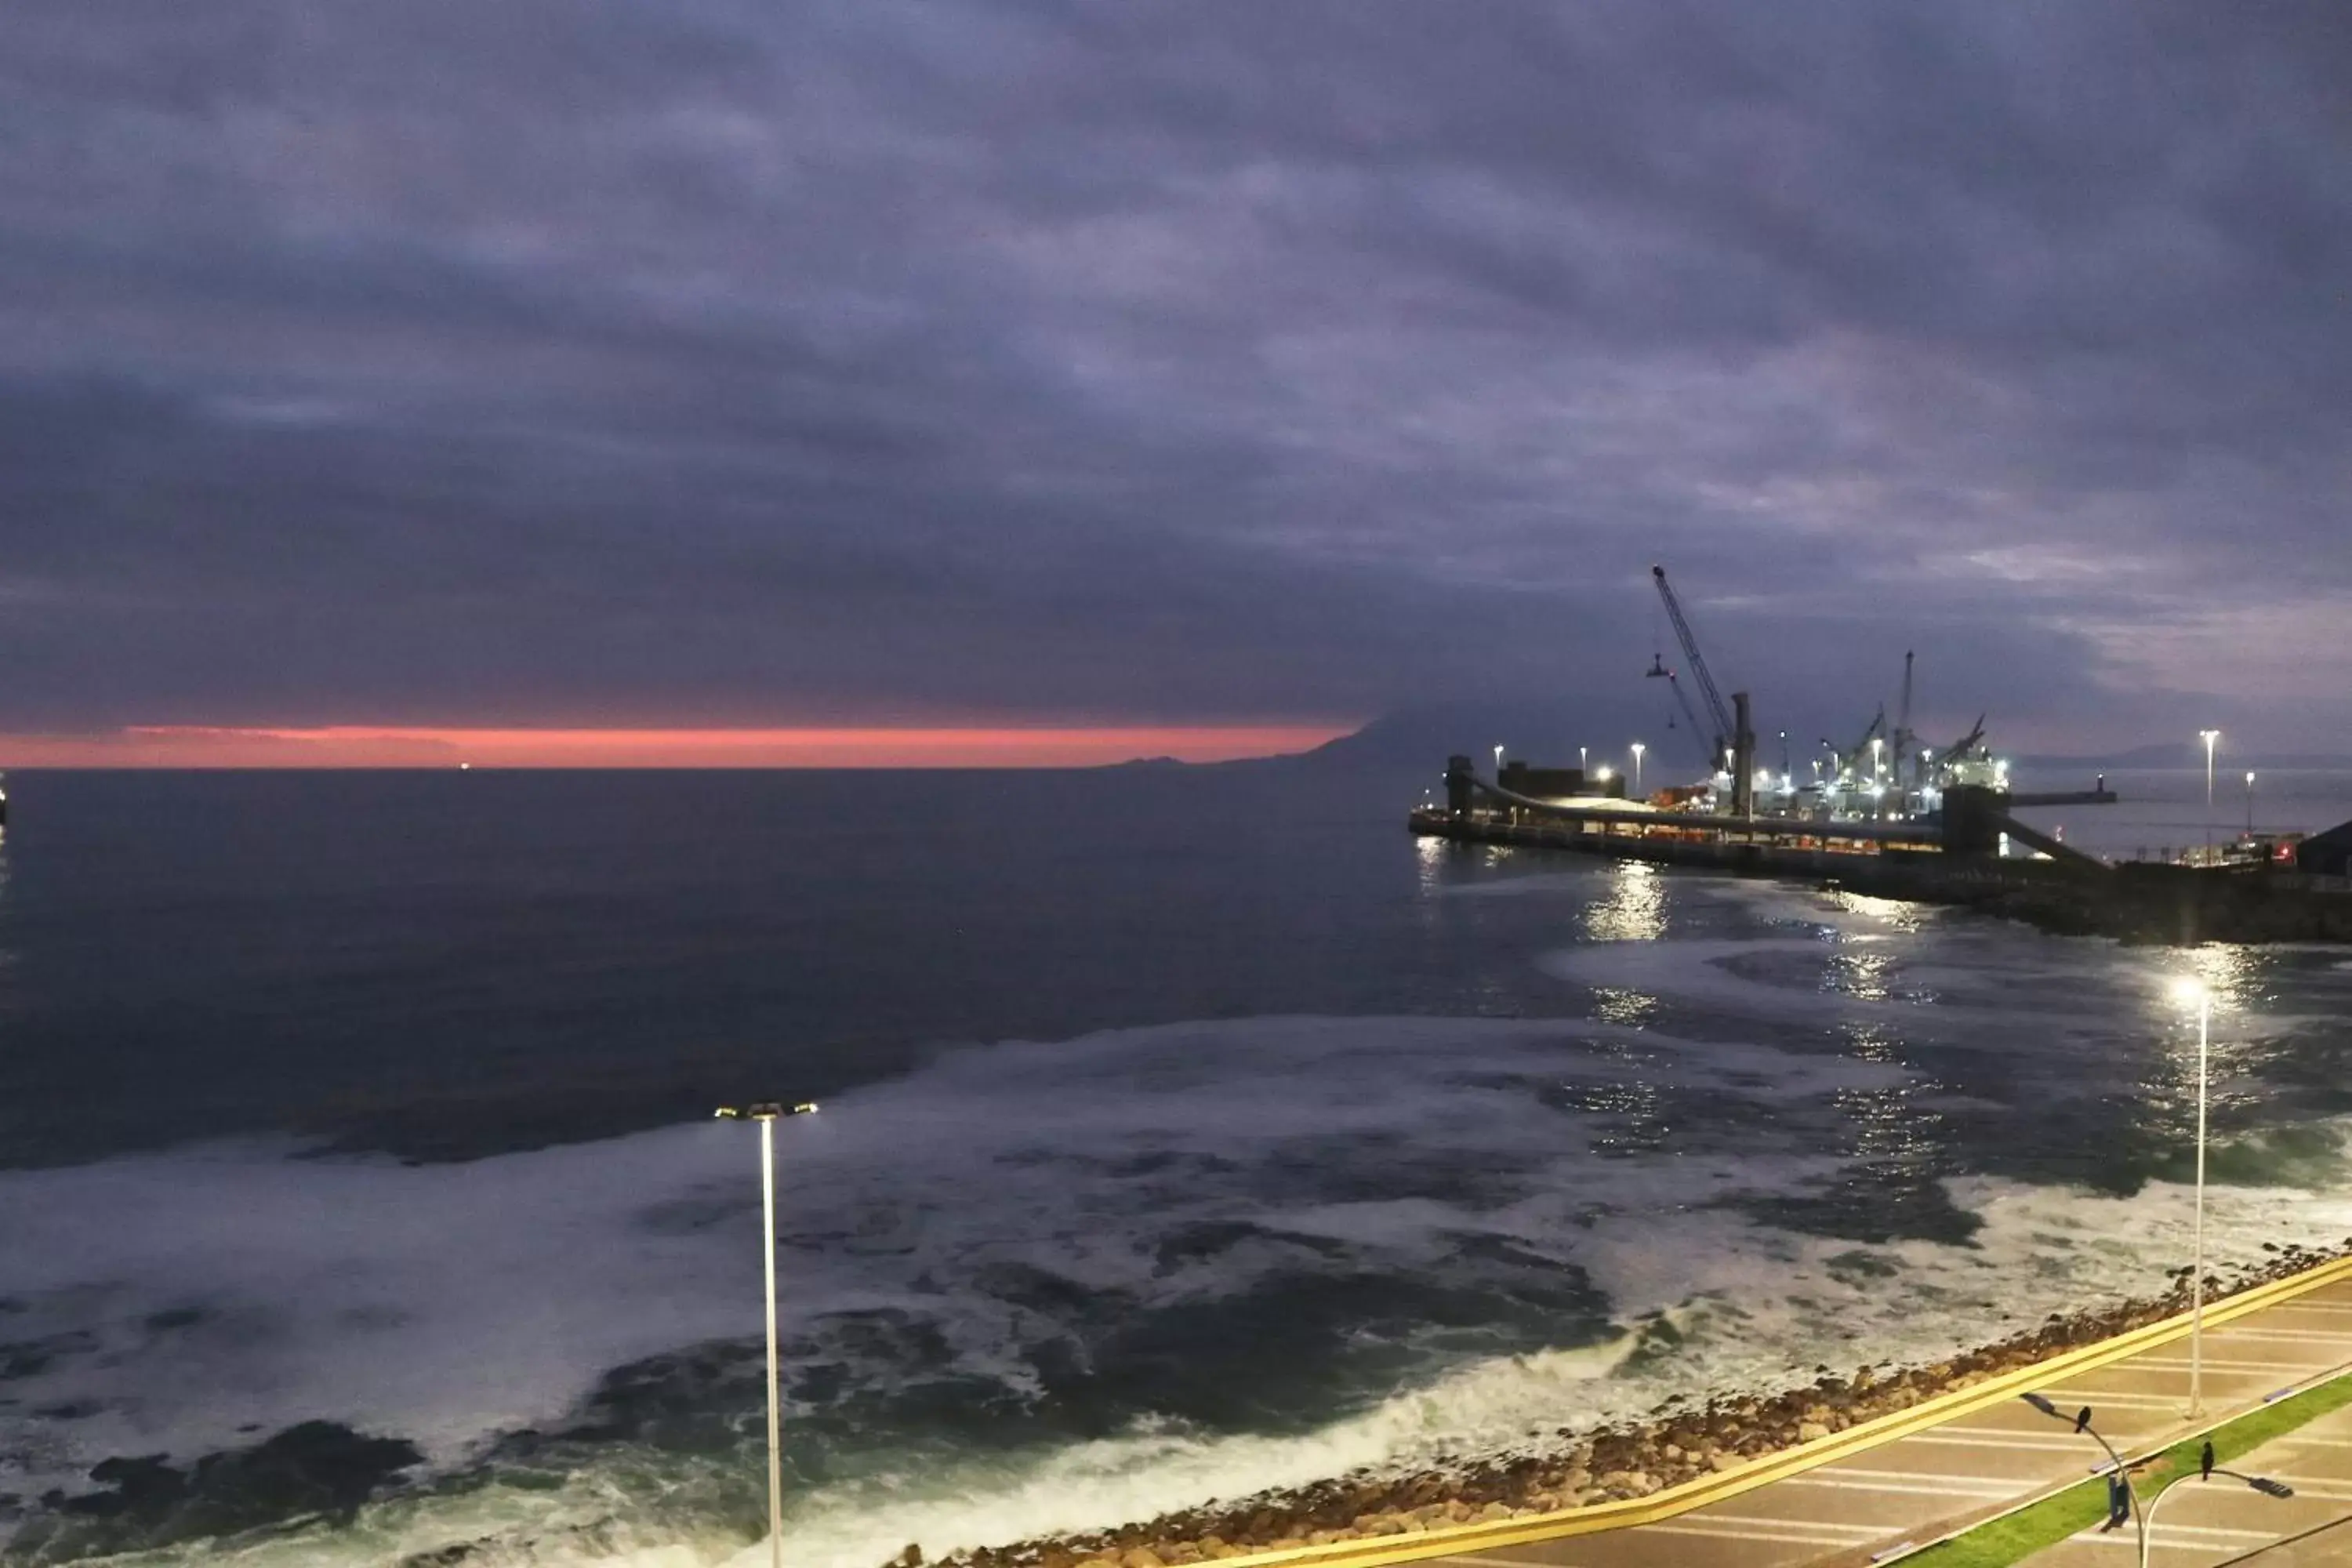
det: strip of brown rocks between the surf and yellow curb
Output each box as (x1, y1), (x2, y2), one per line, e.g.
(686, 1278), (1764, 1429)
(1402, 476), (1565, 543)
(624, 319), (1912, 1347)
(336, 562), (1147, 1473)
(908, 1236), (2352, 1568)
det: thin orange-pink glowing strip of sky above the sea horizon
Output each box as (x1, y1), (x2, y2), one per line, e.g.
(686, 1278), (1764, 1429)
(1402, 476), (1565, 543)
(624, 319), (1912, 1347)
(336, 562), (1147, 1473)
(0, 724), (1355, 769)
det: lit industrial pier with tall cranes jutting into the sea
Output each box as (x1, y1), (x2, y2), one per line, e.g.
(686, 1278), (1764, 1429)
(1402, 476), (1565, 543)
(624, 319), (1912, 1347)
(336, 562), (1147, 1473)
(1409, 567), (2352, 940)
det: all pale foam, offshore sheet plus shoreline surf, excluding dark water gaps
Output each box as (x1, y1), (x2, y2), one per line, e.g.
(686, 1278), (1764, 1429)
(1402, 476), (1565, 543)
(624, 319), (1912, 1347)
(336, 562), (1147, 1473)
(13, 900), (2352, 1568)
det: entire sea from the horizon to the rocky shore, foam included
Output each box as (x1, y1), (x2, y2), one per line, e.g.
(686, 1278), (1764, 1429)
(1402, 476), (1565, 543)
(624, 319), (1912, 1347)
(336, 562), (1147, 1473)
(0, 767), (2352, 1568)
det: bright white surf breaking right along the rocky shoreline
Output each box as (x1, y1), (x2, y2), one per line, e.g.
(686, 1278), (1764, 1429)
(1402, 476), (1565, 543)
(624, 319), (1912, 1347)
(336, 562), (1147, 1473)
(92, 1152), (2352, 1568)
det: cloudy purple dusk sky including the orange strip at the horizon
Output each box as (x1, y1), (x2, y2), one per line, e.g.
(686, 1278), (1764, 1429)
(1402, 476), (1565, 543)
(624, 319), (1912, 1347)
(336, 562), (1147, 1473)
(0, 0), (2352, 764)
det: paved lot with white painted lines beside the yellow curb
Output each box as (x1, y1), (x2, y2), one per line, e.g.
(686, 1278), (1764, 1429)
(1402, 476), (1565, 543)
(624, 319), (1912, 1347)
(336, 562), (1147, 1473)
(1435, 1281), (2352, 1568)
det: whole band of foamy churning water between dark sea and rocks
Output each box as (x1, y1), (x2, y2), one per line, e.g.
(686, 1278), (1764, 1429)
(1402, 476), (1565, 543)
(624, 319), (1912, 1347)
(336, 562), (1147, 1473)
(13, 867), (2352, 1568)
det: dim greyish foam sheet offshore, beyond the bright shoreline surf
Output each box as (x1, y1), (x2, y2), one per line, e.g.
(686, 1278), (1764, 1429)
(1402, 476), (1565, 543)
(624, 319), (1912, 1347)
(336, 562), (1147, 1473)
(0, 1018), (1891, 1481)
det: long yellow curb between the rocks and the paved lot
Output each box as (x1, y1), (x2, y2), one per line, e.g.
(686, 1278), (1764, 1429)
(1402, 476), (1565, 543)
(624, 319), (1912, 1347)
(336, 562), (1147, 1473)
(1162, 1258), (2352, 1568)
